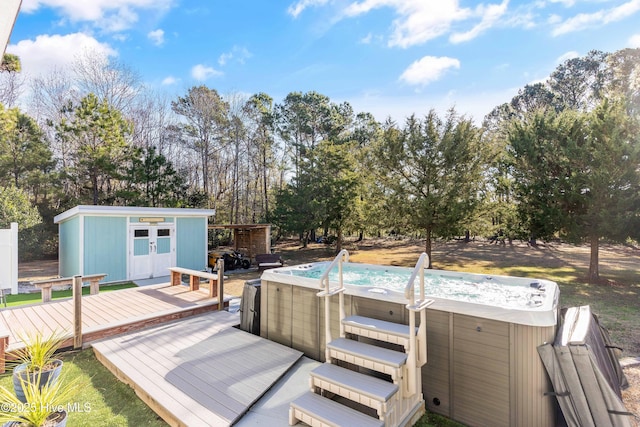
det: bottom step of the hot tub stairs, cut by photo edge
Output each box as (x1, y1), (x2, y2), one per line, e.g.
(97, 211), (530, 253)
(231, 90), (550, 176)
(289, 392), (384, 427)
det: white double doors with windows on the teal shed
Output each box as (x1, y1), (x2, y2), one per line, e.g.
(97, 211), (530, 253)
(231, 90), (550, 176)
(129, 225), (176, 280)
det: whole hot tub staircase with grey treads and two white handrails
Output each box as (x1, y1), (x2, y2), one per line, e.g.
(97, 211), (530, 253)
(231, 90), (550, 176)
(289, 251), (433, 427)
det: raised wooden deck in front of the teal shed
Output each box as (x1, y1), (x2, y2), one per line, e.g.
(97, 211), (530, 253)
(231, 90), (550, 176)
(0, 284), (231, 351)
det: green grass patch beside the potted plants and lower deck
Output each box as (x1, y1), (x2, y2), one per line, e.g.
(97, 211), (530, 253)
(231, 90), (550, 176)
(0, 349), (167, 427)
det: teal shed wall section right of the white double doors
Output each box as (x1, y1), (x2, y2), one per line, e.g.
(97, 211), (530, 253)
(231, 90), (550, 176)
(176, 218), (207, 270)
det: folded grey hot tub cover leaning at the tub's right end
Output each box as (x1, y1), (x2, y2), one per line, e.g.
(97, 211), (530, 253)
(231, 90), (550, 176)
(538, 306), (633, 427)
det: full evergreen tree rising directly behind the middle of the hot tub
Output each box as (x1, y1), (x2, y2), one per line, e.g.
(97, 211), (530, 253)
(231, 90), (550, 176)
(377, 109), (485, 264)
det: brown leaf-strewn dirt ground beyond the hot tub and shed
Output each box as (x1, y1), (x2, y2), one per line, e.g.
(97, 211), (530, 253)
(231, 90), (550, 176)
(18, 239), (640, 426)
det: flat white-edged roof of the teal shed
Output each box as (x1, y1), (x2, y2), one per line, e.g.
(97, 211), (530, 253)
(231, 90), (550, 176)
(53, 205), (216, 224)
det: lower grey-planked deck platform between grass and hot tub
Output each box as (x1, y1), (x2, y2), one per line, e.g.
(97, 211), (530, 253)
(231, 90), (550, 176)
(93, 311), (302, 427)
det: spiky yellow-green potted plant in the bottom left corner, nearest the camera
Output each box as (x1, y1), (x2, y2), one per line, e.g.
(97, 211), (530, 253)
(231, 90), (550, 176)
(0, 371), (78, 427)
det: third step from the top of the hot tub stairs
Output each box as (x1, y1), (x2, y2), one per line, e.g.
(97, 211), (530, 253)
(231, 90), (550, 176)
(311, 363), (398, 412)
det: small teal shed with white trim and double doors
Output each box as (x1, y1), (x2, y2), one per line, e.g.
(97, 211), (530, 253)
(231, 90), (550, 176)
(54, 206), (215, 282)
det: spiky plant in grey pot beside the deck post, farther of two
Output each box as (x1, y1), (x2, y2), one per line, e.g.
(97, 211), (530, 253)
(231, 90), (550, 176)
(8, 332), (64, 402)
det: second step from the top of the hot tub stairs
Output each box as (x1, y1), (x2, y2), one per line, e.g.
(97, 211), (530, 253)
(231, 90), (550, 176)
(327, 338), (407, 382)
